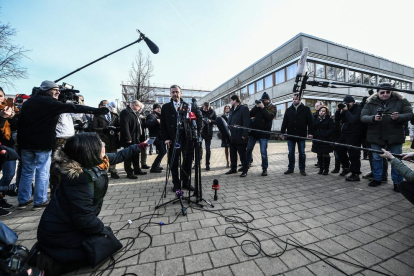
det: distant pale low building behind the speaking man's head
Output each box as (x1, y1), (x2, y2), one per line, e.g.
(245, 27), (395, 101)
(121, 83), (210, 110)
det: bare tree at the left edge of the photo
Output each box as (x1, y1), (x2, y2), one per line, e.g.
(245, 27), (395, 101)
(0, 22), (29, 88)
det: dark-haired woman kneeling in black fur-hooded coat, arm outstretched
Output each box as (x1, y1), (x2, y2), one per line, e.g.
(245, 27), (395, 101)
(36, 133), (148, 275)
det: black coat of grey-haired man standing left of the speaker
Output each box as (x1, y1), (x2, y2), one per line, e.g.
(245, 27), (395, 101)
(119, 106), (142, 147)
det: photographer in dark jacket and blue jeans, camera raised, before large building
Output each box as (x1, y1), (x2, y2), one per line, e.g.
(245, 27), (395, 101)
(246, 92), (276, 176)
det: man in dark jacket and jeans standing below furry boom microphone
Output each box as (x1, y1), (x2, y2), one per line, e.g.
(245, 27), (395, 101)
(280, 93), (313, 175)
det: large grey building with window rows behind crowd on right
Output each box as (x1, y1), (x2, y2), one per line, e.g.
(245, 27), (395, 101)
(201, 33), (414, 130)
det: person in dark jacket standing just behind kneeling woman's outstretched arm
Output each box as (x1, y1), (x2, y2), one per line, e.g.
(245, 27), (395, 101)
(92, 100), (121, 179)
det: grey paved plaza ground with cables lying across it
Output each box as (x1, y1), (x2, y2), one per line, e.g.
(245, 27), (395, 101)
(3, 141), (414, 276)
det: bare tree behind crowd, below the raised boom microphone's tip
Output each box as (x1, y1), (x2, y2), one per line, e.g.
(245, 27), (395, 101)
(129, 50), (155, 110)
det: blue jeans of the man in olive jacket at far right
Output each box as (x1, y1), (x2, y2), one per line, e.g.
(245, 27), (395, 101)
(371, 144), (403, 184)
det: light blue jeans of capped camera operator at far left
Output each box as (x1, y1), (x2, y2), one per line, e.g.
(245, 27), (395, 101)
(17, 150), (52, 205)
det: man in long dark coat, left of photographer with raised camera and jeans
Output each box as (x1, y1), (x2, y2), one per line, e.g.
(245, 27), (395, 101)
(226, 95), (250, 177)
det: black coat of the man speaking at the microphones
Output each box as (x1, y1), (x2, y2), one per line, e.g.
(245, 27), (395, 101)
(161, 99), (202, 141)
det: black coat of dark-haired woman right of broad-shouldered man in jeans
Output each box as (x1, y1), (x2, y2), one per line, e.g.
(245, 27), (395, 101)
(312, 115), (335, 153)
